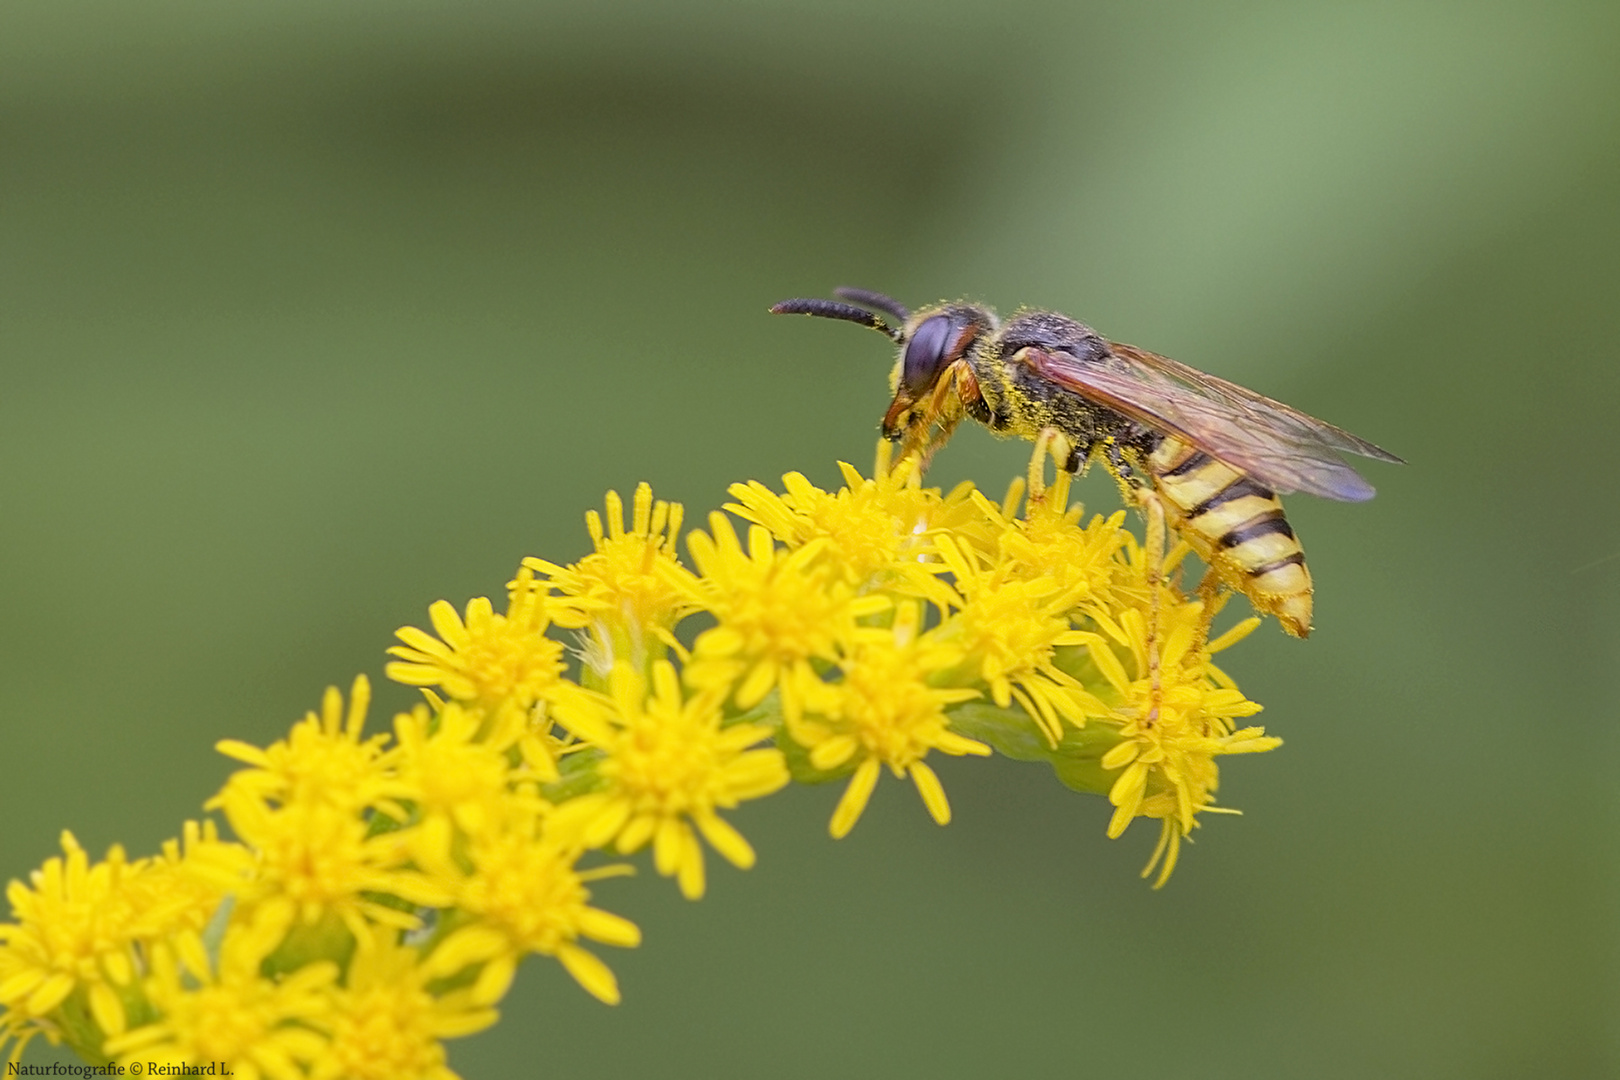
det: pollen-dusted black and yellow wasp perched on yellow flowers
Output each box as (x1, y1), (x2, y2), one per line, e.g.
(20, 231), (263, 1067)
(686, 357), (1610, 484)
(771, 288), (1401, 638)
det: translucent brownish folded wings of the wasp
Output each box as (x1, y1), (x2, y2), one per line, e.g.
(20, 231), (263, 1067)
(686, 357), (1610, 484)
(1019, 343), (1400, 502)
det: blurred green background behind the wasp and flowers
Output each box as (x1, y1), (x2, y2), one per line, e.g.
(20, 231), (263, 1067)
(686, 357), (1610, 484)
(0, 0), (1620, 1080)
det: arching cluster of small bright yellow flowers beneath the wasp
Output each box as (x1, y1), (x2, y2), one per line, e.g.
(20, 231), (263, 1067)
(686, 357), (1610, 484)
(0, 446), (1278, 1080)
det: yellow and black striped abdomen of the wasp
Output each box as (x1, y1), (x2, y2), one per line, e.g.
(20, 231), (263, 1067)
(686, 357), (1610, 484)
(1147, 437), (1311, 638)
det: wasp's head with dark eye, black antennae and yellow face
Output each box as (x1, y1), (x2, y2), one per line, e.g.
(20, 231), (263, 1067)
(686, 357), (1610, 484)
(771, 288), (996, 457)
